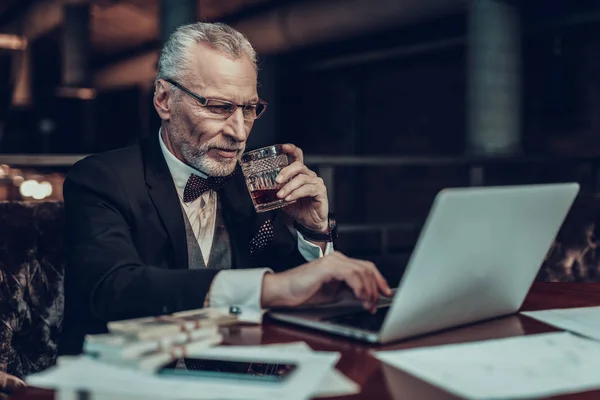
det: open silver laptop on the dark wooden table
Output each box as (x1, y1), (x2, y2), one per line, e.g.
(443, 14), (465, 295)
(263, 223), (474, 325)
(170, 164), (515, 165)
(269, 183), (579, 343)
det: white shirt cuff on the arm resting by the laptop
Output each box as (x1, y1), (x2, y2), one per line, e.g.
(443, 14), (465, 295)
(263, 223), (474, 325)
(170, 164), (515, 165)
(208, 268), (273, 323)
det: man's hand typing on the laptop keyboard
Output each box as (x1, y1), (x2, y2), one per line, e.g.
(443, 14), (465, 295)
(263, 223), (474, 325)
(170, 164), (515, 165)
(261, 251), (392, 312)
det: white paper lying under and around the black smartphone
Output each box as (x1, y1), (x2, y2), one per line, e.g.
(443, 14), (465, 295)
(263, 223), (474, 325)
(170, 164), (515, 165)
(26, 346), (339, 400)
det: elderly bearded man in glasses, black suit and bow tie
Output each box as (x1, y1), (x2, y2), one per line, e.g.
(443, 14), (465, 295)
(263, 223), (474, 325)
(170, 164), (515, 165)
(61, 23), (391, 354)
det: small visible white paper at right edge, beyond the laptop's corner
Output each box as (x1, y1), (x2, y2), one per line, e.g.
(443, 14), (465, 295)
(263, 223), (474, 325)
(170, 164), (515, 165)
(521, 307), (600, 340)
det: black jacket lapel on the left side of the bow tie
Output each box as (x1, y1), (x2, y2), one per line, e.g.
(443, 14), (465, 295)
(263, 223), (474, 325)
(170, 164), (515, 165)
(144, 137), (188, 269)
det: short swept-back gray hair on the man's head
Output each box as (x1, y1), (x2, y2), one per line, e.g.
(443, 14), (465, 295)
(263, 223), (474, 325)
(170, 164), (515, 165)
(156, 22), (258, 84)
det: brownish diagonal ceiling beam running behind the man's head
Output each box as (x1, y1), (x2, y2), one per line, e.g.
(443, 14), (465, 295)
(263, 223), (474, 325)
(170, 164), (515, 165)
(95, 0), (466, 90)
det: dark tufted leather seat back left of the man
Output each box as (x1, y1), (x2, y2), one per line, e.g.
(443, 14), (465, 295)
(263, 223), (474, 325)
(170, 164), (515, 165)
(0, 202), (64, 377)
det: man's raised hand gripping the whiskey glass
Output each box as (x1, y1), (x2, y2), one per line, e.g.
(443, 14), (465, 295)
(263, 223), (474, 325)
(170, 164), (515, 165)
(276, 144), (329, 232)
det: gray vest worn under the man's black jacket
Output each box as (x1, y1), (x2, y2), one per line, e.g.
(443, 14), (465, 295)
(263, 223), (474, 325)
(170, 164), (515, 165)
(182, 198), (231, 269)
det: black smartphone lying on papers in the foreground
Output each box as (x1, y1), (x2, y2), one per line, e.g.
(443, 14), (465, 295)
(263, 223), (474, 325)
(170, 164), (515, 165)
(157, 357), (297, 382)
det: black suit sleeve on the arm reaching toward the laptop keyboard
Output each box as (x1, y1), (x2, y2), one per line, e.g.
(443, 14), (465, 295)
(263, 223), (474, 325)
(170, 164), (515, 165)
(64, 156), (218, 321)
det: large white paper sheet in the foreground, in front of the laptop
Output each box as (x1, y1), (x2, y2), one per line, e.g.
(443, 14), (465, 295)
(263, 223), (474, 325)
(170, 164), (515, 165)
(373, 332), (600, 399)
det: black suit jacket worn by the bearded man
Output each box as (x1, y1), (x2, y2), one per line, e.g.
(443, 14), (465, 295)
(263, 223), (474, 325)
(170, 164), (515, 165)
(59, 136), (306, 354)
